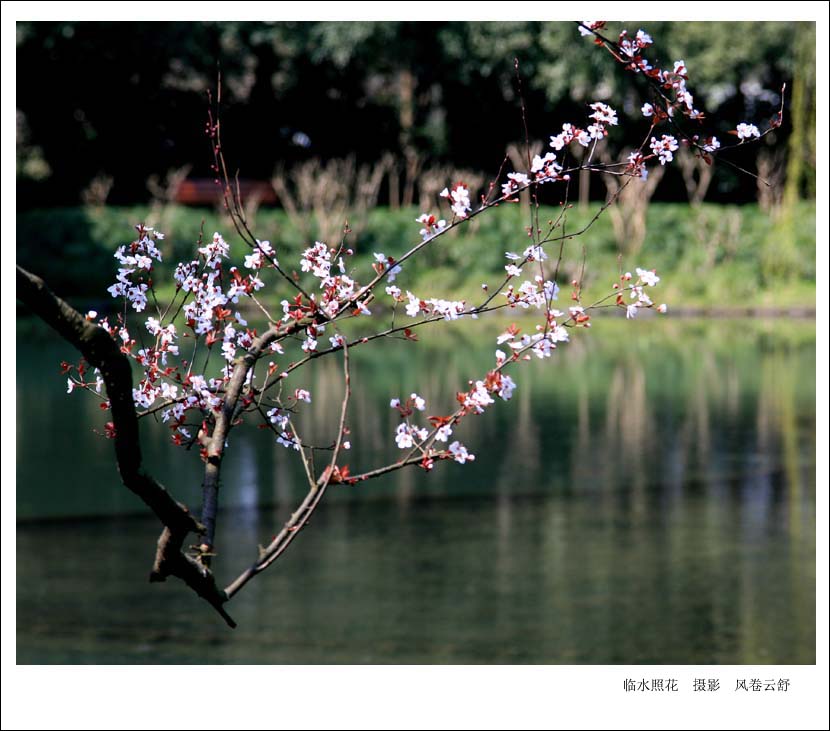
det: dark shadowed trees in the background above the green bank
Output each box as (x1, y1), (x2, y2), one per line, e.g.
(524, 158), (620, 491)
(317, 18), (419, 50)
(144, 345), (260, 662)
(17, 21), (815, 207)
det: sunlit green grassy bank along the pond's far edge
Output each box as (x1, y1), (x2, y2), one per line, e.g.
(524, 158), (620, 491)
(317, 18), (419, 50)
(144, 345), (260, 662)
(17, 202), (816, 309)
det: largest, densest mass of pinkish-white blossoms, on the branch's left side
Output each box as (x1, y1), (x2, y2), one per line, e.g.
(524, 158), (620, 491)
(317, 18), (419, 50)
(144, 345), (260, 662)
(92, 225), (316, 456)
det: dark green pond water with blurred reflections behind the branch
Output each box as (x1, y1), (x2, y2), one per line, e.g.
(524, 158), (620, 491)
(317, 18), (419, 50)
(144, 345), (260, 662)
(17, 320), (816, 663)
